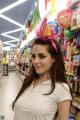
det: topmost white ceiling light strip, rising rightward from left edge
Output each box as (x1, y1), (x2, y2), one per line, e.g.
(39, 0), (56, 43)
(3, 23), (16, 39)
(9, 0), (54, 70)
(0, 0), (27, 14)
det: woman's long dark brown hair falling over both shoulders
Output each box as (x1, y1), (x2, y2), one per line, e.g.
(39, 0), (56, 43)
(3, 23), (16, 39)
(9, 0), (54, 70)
(12, 38), (70, 109)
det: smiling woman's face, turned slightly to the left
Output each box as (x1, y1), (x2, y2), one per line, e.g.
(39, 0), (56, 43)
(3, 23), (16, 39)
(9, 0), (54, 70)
(32, 45), (55, 75)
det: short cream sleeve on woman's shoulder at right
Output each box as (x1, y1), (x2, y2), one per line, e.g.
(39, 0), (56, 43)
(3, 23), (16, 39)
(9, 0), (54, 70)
(55, 83), (72, 103)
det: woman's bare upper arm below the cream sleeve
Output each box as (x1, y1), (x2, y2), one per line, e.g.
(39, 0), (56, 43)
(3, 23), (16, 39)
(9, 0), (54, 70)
(58, 100), (71, 120)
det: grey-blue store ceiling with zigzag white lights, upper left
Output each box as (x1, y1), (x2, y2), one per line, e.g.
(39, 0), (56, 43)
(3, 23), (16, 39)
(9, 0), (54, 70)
(0, 0), (35, 47)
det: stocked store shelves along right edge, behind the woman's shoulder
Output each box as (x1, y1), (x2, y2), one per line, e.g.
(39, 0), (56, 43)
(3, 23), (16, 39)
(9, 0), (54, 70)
(65, 0), (80, 120)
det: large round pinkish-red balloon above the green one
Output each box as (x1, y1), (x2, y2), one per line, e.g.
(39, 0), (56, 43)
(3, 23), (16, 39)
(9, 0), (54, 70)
(57, 9), (72, 28)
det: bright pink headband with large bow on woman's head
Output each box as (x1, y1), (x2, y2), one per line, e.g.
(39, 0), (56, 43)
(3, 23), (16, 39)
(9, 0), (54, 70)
(36, 18), (57, 51)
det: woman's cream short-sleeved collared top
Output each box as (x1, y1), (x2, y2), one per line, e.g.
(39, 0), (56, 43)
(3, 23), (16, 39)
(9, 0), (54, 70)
(15, 80), (72, 120)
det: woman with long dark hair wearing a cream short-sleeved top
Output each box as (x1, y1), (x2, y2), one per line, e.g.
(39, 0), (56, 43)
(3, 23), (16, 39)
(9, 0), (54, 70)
(12, 38), (72, 120)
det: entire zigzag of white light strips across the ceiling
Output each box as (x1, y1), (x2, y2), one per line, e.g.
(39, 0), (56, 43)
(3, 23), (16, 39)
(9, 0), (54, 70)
(0, 0), (27, 48)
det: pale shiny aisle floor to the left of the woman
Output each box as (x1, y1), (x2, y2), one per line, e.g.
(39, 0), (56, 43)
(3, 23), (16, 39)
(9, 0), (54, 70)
(0, 71), (22, 120)
